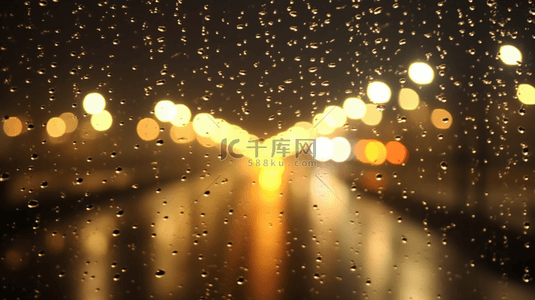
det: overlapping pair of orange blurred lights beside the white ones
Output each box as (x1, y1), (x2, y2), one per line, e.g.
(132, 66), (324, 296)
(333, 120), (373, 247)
(355, 139), (409, 166)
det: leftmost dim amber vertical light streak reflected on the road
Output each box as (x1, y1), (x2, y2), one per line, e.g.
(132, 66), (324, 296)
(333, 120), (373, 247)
(77, 216), (115, 300)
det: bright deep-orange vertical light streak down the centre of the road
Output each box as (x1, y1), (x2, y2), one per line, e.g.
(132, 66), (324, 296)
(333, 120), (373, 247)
(228, 160), (289, 299)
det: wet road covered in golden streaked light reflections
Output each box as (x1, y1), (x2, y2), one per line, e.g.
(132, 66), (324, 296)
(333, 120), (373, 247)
(1, 149), (533, 299)
